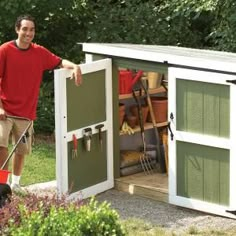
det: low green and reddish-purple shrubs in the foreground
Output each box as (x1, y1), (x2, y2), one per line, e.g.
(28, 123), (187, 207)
(0, 195), (125, 236)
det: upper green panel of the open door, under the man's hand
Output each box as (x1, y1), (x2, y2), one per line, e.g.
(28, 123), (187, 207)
(66, 70), (106, 132)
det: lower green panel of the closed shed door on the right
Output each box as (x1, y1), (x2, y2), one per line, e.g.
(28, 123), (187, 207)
(177, 141), (229, 205)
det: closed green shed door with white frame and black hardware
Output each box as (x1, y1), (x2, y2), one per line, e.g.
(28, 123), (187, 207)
(168, 67), (236, 218)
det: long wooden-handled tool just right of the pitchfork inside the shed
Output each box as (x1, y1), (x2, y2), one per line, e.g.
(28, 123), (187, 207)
(141, 78), (163, 171)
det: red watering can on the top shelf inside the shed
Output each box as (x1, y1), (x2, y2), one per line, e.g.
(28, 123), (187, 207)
(119, 70), (143, 94)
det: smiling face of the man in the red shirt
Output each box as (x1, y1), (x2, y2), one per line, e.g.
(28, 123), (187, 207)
(16, 20), (35, 45)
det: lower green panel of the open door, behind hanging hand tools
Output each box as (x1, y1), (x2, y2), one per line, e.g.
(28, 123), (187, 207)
(68, 132), (107, 193)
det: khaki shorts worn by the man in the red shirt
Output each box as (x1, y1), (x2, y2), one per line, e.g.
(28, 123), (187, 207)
(0, 118), (33, 155)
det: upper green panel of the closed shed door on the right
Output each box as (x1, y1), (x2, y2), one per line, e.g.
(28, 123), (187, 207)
(176, 79), (230, 137)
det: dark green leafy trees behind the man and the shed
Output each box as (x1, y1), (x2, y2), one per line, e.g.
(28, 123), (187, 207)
(0, 0), (233, 132)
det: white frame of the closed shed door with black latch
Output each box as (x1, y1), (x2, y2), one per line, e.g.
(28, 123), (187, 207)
(168, 67), (236, 218)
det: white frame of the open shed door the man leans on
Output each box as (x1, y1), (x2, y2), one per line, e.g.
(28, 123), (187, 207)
(54, 59), (114, 198)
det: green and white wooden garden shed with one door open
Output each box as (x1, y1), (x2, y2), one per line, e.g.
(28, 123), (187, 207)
(55, 43), (236, 218)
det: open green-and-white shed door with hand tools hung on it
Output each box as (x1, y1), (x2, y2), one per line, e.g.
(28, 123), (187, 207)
(54, 59), (114, 198)
